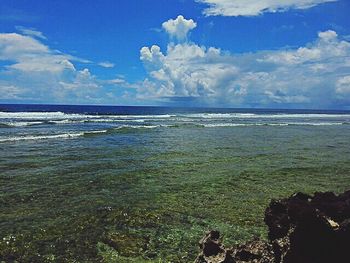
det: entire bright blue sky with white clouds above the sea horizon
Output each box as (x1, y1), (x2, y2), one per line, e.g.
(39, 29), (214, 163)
(0, 0), (350, 109)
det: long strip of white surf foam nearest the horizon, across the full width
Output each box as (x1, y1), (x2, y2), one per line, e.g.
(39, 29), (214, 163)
(0, 111), (350, 131)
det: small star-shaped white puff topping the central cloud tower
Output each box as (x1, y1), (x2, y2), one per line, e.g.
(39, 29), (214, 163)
(162, 15), (197, 41)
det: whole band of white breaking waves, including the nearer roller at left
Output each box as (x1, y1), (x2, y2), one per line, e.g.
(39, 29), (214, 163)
(0, 111), (350, 143)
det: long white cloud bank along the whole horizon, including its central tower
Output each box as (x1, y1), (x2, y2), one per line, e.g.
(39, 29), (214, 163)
(0, 16), (350, 108)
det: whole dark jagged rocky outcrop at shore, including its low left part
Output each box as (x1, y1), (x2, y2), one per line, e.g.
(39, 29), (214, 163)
(196, 191), (350, 263)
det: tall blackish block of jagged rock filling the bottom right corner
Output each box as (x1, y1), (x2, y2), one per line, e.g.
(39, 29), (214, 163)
(265, 192), (350, 263)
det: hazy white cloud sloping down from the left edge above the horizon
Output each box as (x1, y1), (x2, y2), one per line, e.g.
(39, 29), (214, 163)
(0, 33), (109, 103)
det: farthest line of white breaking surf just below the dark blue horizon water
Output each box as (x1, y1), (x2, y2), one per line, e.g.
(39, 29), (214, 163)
(0, 112), (350, 128)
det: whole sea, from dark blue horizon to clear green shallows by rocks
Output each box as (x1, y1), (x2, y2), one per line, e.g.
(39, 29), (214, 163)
(0, 105), (350, 262)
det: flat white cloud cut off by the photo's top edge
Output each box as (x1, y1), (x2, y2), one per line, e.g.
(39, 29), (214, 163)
(196, 0), (337, 16)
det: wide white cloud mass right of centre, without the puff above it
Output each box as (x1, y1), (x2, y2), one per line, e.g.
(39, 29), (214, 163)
(138, 20), (350, 108)
